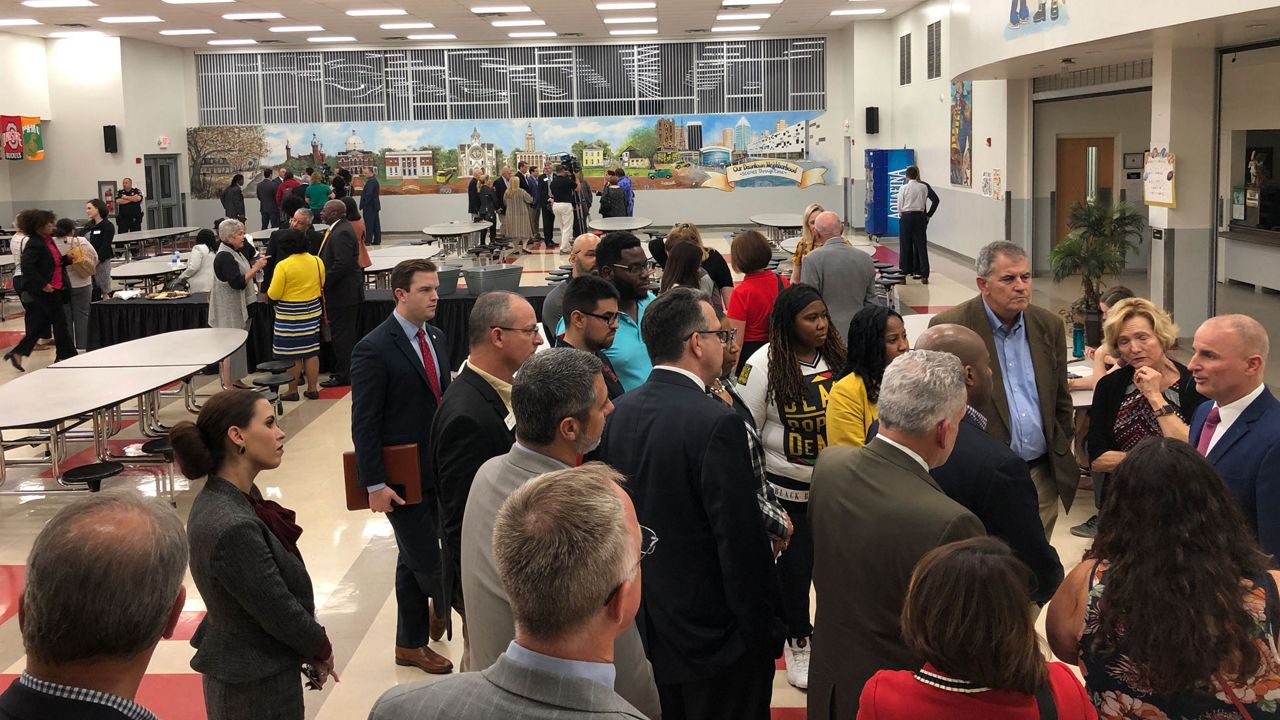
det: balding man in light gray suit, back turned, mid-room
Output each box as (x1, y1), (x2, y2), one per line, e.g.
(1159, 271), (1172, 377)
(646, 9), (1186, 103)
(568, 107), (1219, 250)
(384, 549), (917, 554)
(800, 211), (877, 340)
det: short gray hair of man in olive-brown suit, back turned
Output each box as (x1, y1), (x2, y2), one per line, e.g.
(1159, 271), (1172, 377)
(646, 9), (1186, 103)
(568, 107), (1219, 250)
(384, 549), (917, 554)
(877, 350), (968, 436)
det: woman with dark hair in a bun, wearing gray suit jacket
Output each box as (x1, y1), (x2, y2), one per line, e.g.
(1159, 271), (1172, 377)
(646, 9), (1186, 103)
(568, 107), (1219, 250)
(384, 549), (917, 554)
(169, 389), (338, 720)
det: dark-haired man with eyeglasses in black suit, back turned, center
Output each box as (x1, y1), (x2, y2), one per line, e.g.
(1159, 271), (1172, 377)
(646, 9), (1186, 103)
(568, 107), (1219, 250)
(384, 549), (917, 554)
(598, 288), (786, 720)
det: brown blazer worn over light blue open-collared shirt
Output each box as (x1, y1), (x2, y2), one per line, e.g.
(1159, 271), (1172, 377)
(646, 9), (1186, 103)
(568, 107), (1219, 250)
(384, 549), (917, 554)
(929, 295), (1080, 510)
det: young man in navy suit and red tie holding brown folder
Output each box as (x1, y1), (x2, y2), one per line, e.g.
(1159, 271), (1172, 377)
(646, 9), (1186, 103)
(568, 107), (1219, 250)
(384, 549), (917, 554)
(351, 259), (453, 673)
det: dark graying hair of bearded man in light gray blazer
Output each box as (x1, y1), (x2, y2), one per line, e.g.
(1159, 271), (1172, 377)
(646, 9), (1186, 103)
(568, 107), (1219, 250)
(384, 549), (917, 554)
(511, 347), (602, 445)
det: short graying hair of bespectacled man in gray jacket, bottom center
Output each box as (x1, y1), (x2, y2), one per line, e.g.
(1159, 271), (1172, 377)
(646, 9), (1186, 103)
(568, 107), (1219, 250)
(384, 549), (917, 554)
(493, 462), (631, 641)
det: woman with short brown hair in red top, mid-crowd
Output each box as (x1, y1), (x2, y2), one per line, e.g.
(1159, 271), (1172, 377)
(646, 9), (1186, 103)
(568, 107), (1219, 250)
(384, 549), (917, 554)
(724, 231), (787, 372)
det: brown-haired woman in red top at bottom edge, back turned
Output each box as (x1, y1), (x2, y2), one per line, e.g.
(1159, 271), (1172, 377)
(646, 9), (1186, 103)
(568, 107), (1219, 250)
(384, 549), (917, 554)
(858, 537), (1098, 720)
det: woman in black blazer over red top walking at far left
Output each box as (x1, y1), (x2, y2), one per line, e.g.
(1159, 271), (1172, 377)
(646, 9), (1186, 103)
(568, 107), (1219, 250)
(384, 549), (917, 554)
(4, 204), (76, 372)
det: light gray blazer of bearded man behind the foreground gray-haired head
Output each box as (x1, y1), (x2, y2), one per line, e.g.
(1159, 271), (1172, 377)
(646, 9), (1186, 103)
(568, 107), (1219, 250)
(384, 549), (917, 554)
(462, 446), (662, 720)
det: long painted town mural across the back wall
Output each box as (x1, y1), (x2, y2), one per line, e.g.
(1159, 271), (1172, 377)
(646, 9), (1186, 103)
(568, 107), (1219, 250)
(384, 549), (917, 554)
(187, 110), (829, 199)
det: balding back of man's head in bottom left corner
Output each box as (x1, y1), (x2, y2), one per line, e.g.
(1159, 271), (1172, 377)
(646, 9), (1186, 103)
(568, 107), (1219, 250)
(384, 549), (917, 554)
(22, 489), (187, 665)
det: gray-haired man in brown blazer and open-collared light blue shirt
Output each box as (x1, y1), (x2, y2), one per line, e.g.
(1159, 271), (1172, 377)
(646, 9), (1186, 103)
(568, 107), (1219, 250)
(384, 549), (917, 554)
(929, 242), (1080, 537)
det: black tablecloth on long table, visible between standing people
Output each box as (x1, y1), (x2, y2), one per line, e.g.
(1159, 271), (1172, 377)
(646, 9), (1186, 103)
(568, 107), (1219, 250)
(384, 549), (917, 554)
(88, 286), (552, 370)
